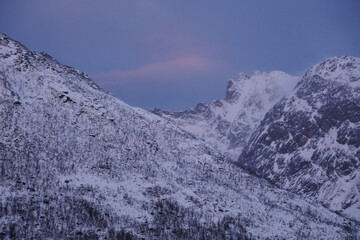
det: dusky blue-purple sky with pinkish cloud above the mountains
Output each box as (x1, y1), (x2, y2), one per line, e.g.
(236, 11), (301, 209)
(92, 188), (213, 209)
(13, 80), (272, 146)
(0, 0), (360, 110)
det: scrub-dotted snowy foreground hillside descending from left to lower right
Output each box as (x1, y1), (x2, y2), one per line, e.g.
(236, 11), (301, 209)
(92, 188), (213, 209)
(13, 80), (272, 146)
(0, 34), (359, 239)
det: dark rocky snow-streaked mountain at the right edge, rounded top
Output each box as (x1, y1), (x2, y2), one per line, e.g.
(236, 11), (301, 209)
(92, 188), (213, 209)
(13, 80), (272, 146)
(239, 57), (360, 221)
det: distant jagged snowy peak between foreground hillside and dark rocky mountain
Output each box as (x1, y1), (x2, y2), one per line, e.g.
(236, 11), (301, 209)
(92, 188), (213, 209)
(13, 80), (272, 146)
(151, 71), (299, 160)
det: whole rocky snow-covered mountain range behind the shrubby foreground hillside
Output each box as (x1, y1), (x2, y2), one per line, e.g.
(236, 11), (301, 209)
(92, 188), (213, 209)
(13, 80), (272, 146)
(151, 54), (360, 221)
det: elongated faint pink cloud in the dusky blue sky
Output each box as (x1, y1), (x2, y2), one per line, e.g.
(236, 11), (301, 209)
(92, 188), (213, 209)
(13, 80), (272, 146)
(94, 55), (214, 83)
